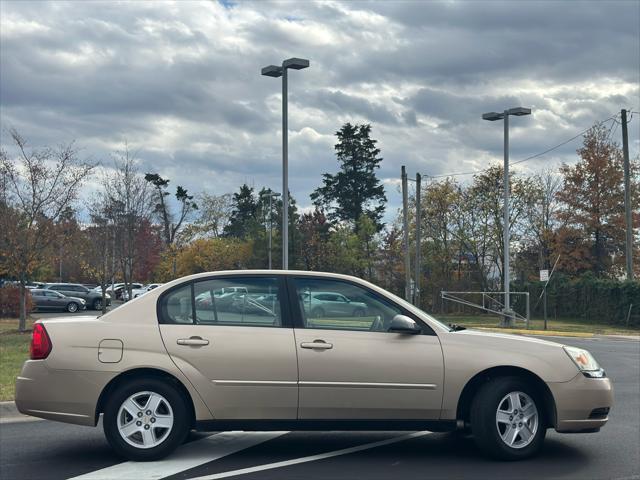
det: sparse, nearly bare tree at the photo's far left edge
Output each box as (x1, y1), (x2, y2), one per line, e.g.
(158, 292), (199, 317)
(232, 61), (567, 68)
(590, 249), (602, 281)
(0, 130), (94, 332)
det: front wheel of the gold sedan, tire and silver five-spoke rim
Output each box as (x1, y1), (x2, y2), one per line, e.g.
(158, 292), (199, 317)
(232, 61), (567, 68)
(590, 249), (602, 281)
(471, 377), (546, 460)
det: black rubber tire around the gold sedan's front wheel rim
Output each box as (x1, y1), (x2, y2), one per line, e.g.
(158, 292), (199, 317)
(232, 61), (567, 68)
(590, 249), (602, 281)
(470, 377), (547, 460)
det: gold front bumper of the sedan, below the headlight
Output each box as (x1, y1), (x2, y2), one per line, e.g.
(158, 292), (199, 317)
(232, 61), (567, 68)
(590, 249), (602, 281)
(547, 373), (613, 433)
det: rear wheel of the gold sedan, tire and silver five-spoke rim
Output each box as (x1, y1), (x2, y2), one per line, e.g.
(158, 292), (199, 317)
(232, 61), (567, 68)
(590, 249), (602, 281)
(104, 379), (190, 461)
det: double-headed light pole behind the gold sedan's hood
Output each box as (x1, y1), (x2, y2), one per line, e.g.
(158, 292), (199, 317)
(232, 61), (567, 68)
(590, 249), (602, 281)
(482, 107), (531, 326)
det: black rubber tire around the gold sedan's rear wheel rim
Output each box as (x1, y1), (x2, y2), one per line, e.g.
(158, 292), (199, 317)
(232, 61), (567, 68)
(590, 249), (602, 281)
(103, 378), (191, 462)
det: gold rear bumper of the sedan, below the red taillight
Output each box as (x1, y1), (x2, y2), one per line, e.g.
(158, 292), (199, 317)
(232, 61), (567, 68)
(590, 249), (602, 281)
(16, 360), (115, 426)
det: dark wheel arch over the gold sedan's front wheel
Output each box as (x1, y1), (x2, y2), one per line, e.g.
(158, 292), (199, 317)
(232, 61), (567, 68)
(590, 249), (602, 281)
(456, 365), (556, 427)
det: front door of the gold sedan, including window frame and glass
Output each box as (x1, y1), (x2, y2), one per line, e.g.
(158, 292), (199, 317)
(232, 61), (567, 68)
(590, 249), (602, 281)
(289, 276), (444, 420)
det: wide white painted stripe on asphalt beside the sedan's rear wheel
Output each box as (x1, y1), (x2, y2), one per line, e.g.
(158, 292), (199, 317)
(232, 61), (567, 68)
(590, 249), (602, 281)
(70, 432), (289, 480)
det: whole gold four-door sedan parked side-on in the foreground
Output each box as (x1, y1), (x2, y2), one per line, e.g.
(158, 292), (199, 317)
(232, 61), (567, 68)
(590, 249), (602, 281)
(16, 271), (613, 461)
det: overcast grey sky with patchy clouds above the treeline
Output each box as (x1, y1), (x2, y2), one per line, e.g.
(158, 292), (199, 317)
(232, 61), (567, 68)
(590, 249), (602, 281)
(0, 0), (640, 220)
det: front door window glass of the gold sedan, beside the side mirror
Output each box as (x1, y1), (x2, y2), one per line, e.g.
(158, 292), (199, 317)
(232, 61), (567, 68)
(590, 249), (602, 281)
(295, 278), (402, 332)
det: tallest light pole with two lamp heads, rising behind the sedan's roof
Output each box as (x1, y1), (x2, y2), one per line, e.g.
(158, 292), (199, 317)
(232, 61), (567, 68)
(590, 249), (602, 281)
(262, 58), (309, 270)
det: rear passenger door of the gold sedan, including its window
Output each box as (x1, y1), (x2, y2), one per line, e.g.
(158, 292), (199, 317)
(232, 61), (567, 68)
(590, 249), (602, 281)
(159, 275), (298, 420)
